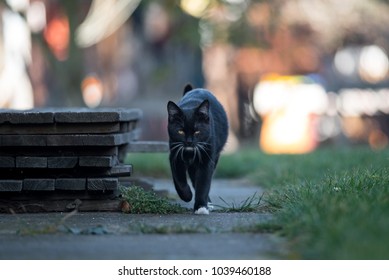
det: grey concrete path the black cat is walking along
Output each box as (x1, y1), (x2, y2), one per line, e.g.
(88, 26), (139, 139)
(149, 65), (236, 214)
(0, 180), (287, 259)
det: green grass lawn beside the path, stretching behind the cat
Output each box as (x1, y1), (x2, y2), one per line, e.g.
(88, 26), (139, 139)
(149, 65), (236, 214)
(127, 146), (389, 259)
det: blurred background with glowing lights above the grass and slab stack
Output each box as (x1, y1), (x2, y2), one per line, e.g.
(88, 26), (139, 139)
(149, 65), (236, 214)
(0, 0), (389, 153)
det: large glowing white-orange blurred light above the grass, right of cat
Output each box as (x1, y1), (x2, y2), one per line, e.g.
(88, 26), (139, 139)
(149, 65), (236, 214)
(253, 75), (328, 154)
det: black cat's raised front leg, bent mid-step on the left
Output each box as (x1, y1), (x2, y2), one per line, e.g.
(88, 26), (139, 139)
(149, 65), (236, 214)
(170, 157), (193, 202)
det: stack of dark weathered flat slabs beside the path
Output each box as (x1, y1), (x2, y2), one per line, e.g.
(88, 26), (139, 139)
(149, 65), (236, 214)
(0, 108), (142, 194)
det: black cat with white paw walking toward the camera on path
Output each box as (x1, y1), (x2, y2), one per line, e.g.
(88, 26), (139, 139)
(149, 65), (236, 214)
(167, 85), (228, 214)
